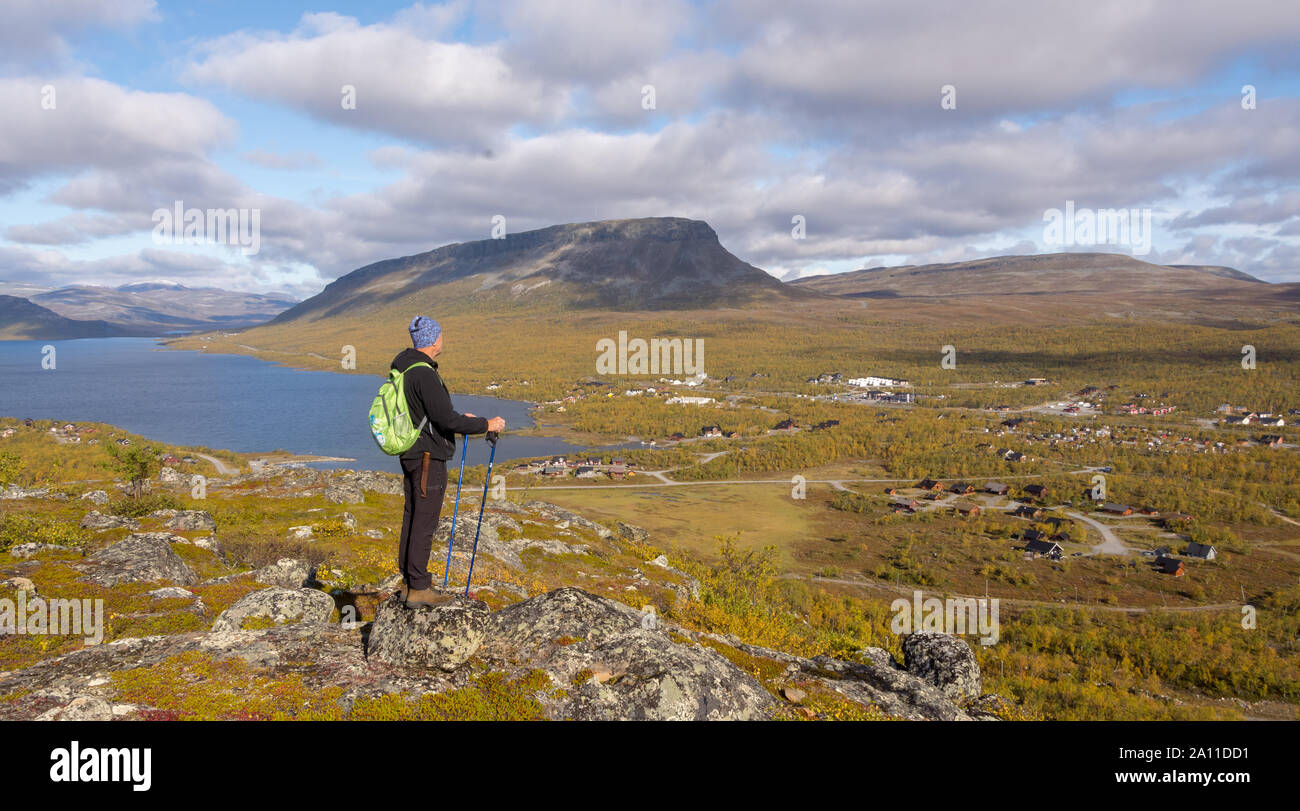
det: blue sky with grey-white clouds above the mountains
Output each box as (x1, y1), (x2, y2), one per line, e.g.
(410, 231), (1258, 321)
(0, 0), (1300, 296)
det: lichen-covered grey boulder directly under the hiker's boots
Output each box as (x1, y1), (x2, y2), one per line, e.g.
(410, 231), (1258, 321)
(365, 595), (491, 672)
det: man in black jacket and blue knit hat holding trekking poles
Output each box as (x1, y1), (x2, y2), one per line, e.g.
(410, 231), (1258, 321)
(391, 316), (506, 608)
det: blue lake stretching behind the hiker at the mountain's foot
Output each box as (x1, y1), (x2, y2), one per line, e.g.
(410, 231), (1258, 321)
(0, 338), (603, 472)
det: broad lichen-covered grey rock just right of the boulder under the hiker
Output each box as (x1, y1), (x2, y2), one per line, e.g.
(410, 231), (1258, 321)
(478, 589), (776, 720)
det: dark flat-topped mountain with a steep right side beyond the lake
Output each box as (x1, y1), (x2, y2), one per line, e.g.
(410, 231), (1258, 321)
(266, 217), (818, 324)
